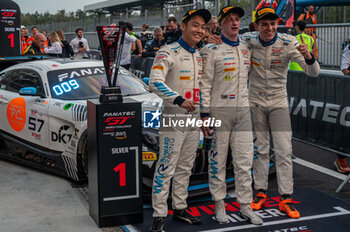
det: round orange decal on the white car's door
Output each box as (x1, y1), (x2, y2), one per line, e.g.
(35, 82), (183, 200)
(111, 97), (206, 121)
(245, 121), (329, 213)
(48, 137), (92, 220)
(7, 97), (26, 132)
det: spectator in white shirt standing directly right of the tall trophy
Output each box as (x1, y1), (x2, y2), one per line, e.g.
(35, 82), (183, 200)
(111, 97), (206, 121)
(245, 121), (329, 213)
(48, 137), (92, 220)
(118, 21), (142, 70)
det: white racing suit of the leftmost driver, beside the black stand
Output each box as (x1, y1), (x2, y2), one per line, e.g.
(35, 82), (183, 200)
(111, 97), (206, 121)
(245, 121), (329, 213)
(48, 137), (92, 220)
(149, 38), (202, 217)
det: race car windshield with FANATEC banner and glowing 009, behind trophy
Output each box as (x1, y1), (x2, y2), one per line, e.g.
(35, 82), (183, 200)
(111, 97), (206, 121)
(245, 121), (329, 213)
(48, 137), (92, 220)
(47, 67), (148, 100)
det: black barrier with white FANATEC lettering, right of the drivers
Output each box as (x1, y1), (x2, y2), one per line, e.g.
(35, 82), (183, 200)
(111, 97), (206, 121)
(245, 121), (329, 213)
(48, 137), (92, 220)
(287, 70), (350, 154)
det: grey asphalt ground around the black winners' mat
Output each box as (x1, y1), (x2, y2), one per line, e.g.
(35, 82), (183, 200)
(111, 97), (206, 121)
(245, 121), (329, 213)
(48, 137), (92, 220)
(0, 141), (350, 232)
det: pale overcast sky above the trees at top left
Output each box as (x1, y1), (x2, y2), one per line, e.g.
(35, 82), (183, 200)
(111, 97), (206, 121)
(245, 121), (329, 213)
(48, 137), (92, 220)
(12, 0), (106, 14)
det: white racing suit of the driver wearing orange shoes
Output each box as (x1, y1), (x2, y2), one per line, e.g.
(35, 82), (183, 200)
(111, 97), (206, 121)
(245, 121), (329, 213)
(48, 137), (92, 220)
(242, 32), (320, 195)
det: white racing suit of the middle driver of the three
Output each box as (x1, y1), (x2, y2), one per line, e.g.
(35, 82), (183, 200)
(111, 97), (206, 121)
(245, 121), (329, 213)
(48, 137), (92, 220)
(200, 39), (253, 204)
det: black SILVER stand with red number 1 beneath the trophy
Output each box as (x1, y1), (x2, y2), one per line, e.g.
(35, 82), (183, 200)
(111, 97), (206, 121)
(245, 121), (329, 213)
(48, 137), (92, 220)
(87, 98), (143, 227)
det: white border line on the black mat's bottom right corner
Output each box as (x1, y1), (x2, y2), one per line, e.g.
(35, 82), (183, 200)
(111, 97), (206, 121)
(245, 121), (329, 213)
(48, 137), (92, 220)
(198, 206), (350, 232)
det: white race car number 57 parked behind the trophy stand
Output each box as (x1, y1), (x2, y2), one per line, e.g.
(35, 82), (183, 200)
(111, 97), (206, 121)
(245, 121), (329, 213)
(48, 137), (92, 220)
(0, 59), (274, 197)
